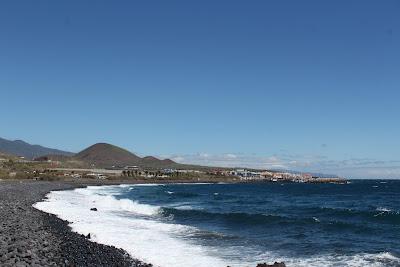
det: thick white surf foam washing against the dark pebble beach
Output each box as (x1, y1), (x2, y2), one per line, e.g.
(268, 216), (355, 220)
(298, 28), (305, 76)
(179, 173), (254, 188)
(34, 187), (234, 267)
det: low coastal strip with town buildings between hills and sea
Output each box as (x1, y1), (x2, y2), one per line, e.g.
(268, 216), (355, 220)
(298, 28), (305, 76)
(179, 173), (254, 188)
(0, 157), (345, 183)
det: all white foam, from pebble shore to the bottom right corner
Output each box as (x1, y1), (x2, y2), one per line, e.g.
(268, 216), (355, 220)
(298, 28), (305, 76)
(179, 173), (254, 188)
(34, 185), (400, 267)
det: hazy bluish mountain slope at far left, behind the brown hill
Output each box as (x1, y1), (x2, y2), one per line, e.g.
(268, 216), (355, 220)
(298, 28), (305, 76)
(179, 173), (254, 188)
(0, 138), (73, 159)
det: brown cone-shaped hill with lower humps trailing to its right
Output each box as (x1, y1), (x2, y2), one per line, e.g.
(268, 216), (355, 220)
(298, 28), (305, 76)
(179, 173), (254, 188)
(73, 143), (180, 168)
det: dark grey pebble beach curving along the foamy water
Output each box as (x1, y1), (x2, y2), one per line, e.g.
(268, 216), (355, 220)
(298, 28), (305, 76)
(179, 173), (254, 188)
(0, 180), (152, 267)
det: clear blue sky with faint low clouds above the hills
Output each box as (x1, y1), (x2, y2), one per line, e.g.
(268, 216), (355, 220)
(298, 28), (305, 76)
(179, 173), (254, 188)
(0, 0), (400, 178)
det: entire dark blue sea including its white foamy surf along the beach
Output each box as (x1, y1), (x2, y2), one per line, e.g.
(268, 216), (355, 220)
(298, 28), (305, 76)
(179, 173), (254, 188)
(35, 180), (400, 267)
